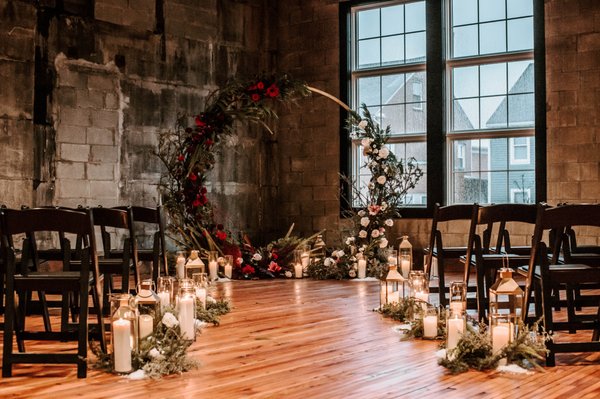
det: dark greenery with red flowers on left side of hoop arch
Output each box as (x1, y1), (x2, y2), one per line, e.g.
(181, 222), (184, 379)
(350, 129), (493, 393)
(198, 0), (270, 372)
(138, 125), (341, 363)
(156, 74), (310, 260)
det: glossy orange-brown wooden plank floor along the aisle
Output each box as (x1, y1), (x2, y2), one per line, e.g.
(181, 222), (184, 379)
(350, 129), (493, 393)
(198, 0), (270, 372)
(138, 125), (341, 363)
(0, 280), (600, 399)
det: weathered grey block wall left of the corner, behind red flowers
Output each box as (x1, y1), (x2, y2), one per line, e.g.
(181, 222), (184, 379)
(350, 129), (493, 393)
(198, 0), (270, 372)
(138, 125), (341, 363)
(0, 0), (273, 239)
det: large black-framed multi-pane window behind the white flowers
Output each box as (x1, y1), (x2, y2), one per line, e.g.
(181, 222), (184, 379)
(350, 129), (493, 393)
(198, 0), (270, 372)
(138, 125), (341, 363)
(340, 0), (546, 217)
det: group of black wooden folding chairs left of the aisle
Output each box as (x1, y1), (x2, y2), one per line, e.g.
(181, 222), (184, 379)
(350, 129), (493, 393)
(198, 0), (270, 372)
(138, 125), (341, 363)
(0, 206), (168, 378)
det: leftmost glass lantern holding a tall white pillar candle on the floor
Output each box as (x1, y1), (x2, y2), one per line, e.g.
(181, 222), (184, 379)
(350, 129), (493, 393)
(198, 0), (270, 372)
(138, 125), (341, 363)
(110, 294), (138, 373)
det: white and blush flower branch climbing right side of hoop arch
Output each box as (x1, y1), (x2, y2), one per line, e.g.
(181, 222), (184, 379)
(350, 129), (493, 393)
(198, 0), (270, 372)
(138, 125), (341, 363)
(346, 104), (423, 277)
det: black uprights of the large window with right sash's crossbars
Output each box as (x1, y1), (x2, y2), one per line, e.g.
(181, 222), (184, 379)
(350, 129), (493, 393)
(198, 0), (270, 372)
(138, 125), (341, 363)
(339, 0), (547, 218)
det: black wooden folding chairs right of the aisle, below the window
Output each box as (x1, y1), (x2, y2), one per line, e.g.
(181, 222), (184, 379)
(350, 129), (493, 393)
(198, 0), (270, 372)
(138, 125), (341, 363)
(425, 204), (600, 366)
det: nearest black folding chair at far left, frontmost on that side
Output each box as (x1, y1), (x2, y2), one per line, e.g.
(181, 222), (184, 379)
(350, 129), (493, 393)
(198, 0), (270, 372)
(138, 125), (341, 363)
(1, 208), (106, 378)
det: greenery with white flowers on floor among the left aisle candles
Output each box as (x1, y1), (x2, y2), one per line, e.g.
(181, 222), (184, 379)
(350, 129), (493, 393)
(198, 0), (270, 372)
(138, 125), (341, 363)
(91, 296), (231, 379)
